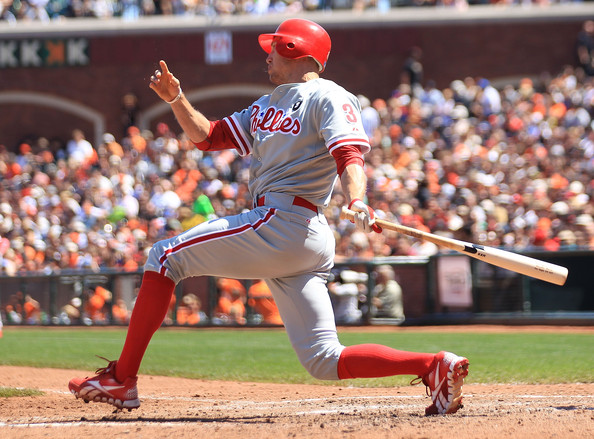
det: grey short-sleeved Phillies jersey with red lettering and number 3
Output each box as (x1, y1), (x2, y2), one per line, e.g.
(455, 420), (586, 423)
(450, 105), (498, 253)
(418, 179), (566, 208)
(224, 78), (369, 206)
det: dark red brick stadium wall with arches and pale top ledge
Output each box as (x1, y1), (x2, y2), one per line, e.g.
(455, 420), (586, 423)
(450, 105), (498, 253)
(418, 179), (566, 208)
(0, 3), (594, 150)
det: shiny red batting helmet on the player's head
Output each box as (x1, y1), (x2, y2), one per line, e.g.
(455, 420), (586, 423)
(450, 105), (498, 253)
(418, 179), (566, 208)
(258, 18), (331, 72)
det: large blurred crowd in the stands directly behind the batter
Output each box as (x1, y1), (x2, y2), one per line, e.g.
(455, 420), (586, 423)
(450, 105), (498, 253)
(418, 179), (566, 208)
(0, 63), (594, 276)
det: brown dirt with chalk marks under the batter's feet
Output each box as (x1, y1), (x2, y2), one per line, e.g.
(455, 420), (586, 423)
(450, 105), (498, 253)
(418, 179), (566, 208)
(0, 328), (594, 439)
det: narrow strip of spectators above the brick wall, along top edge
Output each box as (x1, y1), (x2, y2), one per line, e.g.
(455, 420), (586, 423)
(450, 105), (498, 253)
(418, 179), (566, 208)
(0, 0), (582, 23)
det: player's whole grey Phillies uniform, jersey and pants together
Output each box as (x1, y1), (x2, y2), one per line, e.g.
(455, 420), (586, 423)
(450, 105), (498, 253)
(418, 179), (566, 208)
(145, 79), (370, 379)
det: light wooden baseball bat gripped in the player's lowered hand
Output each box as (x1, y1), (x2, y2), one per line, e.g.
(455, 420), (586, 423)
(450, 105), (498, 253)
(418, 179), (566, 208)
(340, 207), (568, 285)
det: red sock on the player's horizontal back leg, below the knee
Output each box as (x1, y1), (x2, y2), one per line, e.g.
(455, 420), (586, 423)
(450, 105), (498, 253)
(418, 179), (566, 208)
(338, 344), (435, 380)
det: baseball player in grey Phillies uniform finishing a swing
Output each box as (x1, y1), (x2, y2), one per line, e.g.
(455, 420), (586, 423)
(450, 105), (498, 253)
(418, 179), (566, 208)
(69, 19), (468, 414)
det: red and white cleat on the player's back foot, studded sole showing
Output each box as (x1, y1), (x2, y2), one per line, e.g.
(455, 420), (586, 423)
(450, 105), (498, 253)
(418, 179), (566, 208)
(413, 351), (468, 416)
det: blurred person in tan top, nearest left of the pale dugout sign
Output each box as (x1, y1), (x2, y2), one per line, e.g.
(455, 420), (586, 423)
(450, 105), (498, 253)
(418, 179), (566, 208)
(371, 265), (404, 322)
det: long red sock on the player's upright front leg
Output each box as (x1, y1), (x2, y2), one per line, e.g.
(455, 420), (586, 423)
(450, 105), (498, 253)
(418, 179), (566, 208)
(115, 271), (175, 382)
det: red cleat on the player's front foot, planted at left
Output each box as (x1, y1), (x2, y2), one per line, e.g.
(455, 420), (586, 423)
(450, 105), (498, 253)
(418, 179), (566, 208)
(68, 357), (140, 411)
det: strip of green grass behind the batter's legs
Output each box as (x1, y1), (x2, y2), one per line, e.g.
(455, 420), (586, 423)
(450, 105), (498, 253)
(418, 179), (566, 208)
(0, 327), (594, 388)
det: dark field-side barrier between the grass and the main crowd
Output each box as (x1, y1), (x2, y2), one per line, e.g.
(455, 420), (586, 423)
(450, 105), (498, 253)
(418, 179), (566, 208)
(0, 250), (594, 326)
